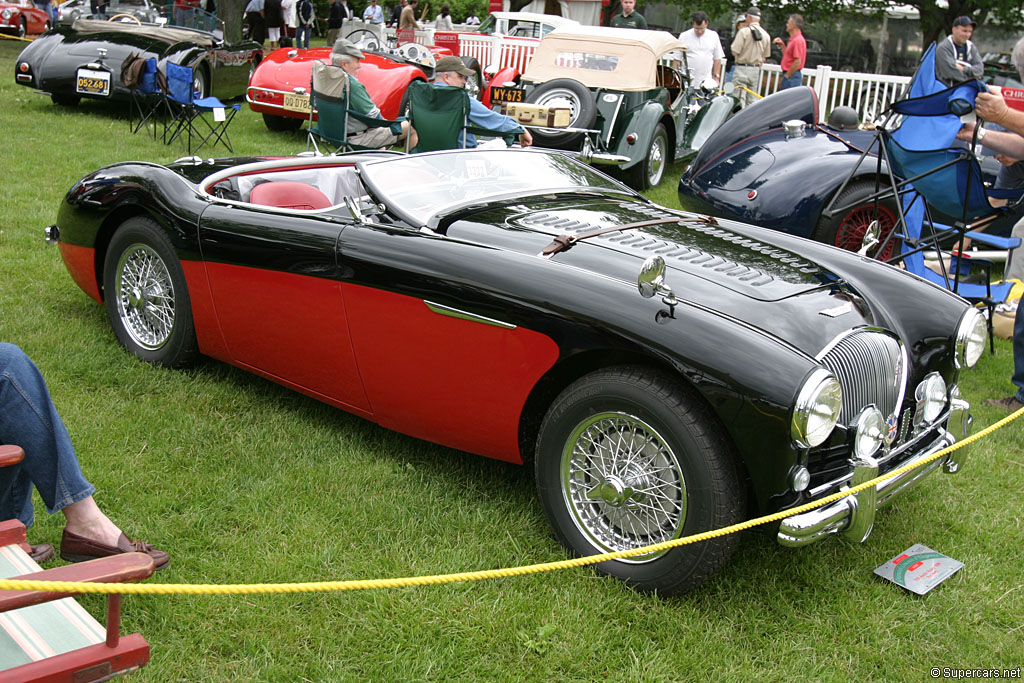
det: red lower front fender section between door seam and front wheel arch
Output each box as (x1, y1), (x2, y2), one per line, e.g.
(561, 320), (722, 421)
(342, 284), (559, 463)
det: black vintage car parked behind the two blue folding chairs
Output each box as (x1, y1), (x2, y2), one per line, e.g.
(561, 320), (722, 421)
(14, 19), (263, 104)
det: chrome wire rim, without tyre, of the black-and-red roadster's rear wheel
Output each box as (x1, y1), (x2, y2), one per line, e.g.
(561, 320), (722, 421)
(115, 244), (174, 350)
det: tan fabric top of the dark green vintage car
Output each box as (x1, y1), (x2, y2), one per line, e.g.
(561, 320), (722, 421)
(522, 27), (686, 91)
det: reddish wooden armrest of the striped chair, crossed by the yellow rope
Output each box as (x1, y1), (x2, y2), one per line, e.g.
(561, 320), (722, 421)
(0, 553), (156, 612)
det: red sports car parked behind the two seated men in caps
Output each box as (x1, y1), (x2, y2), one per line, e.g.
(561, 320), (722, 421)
(246, 43), (452, 130)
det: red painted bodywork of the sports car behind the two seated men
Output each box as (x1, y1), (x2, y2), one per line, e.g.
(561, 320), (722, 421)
(246, 47), (451, 120)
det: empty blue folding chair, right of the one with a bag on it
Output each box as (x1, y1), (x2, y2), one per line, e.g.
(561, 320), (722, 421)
(164, 61), (241, 155)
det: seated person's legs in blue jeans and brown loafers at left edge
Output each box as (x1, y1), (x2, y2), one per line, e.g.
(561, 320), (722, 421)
(0, 343), (170, 569)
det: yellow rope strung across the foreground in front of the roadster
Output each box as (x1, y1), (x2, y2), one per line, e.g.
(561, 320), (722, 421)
(0, 408), (1024, 595)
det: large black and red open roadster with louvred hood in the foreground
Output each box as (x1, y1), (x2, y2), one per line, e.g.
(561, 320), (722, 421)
(47, 151), (986, 594)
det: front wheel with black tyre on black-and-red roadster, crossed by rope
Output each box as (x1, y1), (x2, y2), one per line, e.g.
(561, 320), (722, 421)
(536, 367), (745, 595)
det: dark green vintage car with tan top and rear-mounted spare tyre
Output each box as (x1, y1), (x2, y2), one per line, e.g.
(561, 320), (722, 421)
(485, 27), (739, 189)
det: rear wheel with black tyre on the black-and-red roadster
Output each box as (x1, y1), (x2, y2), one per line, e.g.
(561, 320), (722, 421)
(103, 218), (199, 368)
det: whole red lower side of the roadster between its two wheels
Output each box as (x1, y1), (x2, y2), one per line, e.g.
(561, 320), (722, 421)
(182, 259), (559, 463)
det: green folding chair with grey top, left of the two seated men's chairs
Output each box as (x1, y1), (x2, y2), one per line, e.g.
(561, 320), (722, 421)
(306, 61), (404, 155)
